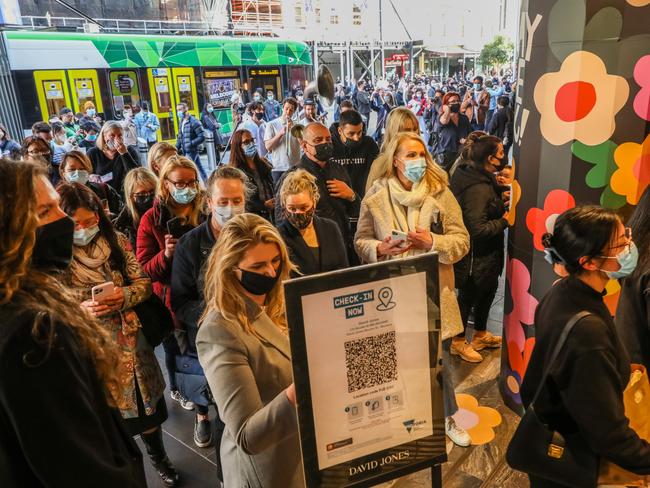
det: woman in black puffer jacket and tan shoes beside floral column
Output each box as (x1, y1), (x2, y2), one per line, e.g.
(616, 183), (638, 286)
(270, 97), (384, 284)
(451, 133), (508, 363)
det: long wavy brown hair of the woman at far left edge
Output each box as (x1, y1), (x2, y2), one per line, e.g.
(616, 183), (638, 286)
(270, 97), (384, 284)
(0, 160), (118, 404)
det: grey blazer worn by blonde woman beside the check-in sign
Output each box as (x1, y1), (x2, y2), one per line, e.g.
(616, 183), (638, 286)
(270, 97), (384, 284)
(196, 301), (305, 488)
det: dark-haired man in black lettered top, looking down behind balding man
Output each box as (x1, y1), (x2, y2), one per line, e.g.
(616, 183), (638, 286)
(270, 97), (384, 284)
(330, 110), (379, 198)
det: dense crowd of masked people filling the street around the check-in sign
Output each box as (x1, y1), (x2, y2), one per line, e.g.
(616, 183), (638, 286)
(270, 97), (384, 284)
(0, 67), (650, 488)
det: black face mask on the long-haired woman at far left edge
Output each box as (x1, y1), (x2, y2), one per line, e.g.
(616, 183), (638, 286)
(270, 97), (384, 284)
(32, 217), (74, 269)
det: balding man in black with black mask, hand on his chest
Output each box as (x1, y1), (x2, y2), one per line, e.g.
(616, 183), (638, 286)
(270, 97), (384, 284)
(275, 123), (360, 252)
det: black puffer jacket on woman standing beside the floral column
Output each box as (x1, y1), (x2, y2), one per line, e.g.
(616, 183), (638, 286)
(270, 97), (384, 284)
(451, 163), (508, 288)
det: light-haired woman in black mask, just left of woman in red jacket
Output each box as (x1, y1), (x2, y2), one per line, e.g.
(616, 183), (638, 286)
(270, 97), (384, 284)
(113, 168), (158, 249)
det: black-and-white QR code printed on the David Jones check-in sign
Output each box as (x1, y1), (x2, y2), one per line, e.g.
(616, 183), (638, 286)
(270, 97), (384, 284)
(345, 332), (397, 393)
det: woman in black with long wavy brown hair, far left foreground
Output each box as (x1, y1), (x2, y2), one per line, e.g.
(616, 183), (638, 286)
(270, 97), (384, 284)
(0, 160), (147, 488)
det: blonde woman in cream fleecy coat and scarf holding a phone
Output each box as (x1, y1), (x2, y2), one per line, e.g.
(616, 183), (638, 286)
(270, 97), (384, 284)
(355, 132), (471, 447)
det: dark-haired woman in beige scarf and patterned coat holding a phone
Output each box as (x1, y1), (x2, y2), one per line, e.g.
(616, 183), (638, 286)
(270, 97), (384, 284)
(57, 183), (178, 486)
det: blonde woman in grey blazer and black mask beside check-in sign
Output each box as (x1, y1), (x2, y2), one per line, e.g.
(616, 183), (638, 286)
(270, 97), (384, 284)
(196, 214), (304, 488)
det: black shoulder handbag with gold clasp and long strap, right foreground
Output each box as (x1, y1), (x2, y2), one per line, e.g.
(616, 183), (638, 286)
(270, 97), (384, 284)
(506, 311), (598, 488)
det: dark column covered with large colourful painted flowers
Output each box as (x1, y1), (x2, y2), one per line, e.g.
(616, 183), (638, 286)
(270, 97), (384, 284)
(500, 0), (650, 412)
